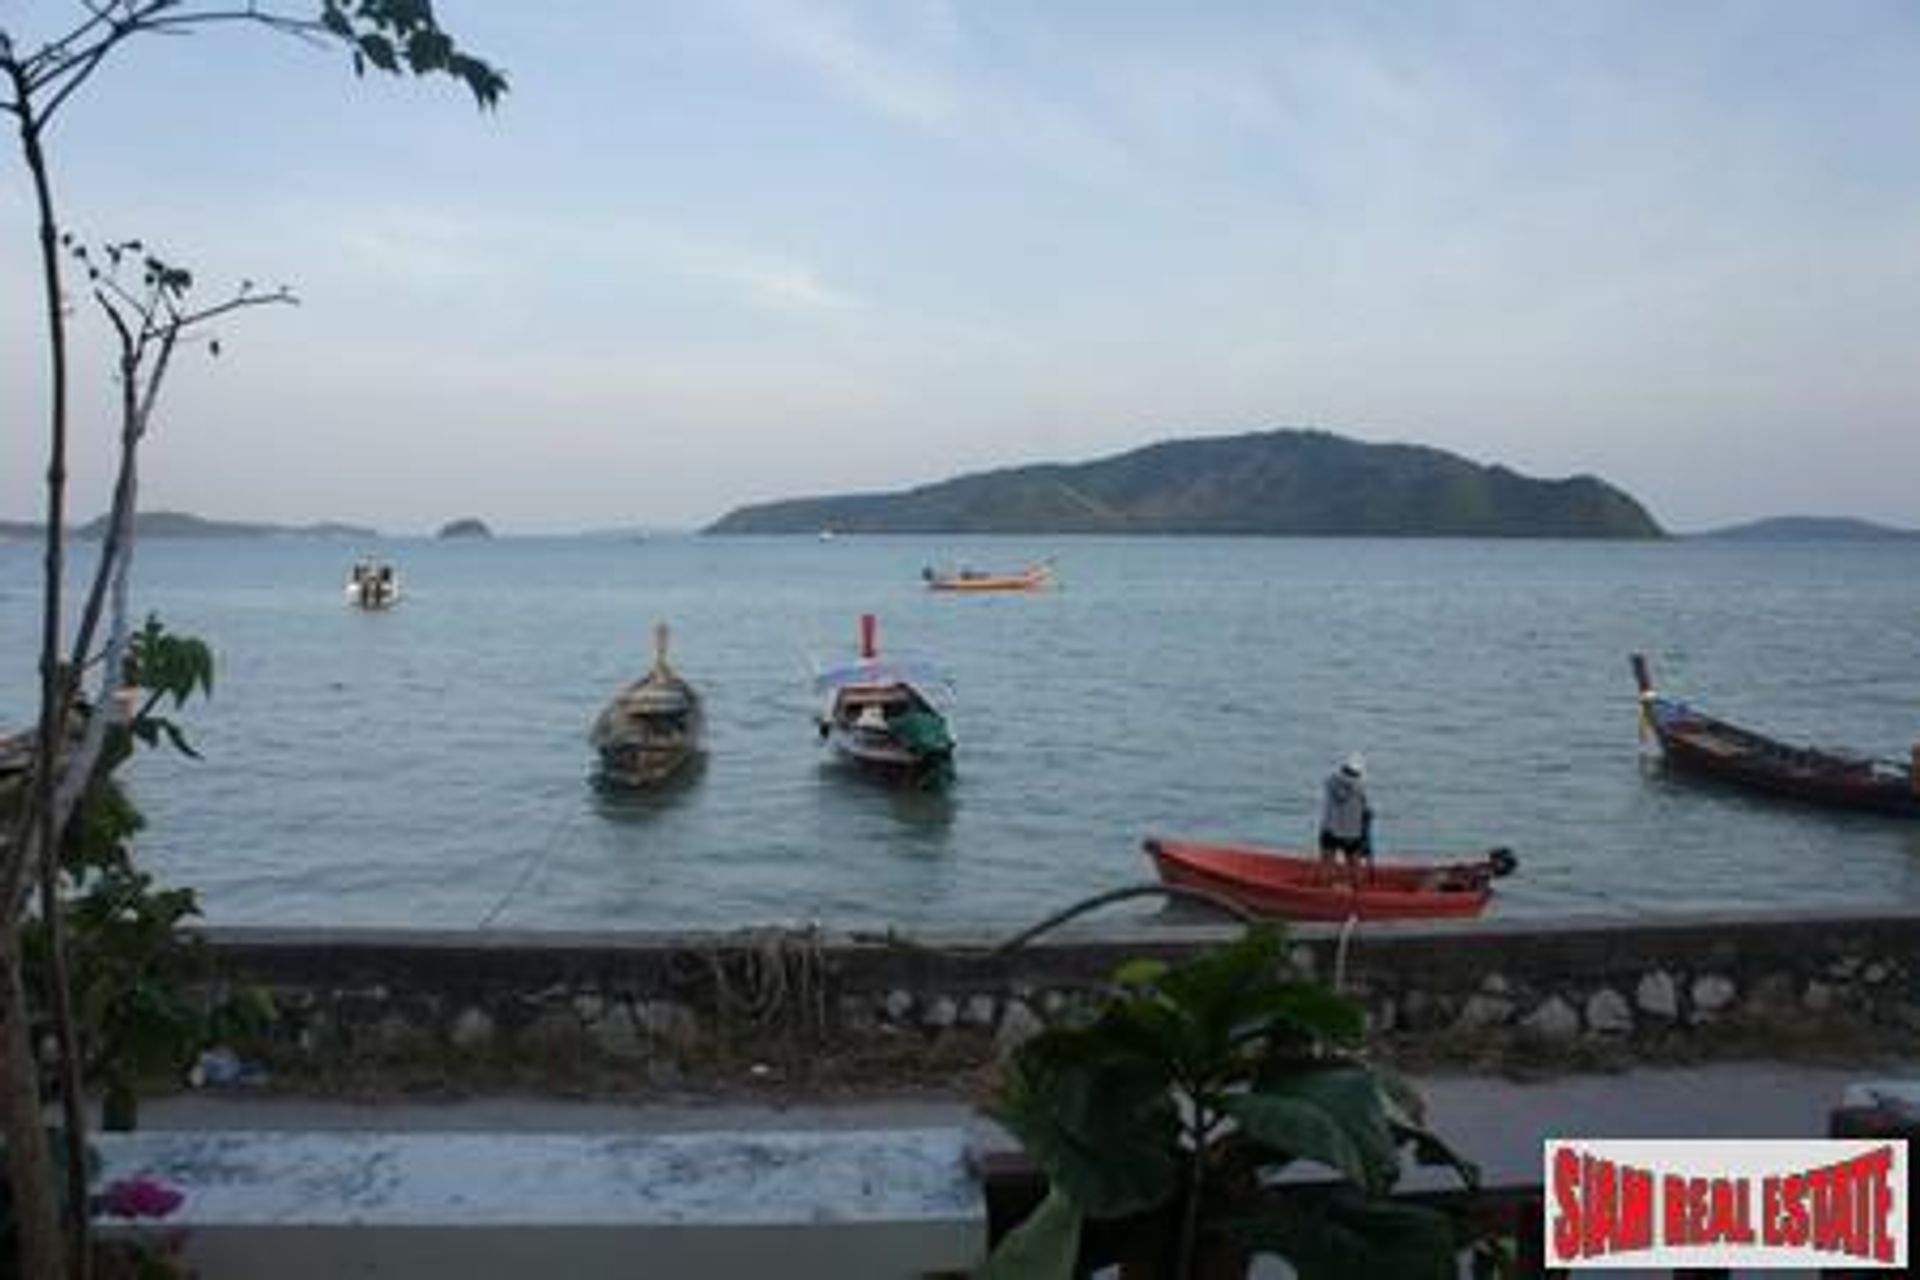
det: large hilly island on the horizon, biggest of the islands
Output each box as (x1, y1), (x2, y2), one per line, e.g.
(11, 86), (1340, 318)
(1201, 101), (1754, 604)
(707, 430), (1663, 537)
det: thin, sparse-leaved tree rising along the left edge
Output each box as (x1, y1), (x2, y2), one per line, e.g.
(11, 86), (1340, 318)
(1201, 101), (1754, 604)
(0, 0), (507, 1280)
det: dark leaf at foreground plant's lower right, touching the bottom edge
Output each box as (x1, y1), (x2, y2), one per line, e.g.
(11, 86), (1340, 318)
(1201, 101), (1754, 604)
(1219, 1188), (1457, 1280)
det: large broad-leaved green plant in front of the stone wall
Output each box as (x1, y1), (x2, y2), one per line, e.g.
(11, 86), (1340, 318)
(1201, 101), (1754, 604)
(985, 925), (1478, 1280)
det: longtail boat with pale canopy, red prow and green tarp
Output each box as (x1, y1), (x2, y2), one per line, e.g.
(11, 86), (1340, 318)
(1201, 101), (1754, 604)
(814, 614), (954, 787)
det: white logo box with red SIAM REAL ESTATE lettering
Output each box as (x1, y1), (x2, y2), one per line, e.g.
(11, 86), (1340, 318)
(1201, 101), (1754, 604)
(1546, 1138), (1907, 1270)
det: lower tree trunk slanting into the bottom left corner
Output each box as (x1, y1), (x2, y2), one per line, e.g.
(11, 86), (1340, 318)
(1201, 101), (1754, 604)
(0, 919), (67, 1280)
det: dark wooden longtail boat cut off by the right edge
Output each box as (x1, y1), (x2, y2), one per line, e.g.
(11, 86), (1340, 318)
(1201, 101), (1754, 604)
(1630, 652), (1920, 818)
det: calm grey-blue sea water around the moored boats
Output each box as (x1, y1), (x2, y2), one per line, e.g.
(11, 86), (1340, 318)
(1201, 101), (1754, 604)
(0, 537), (1920, 931)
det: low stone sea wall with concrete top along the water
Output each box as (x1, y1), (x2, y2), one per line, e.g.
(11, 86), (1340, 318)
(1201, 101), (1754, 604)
(191, 915), (1920, 1090)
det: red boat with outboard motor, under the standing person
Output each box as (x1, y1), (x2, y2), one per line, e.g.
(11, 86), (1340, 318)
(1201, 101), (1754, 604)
(1144, 839), (1517, 921)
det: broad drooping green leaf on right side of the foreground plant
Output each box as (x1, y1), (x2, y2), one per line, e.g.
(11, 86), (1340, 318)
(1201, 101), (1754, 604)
(1221, 1067), (1400, 1192)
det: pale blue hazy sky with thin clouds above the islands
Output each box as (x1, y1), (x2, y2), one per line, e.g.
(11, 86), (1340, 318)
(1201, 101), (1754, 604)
(0, 0), (1920, 532)
